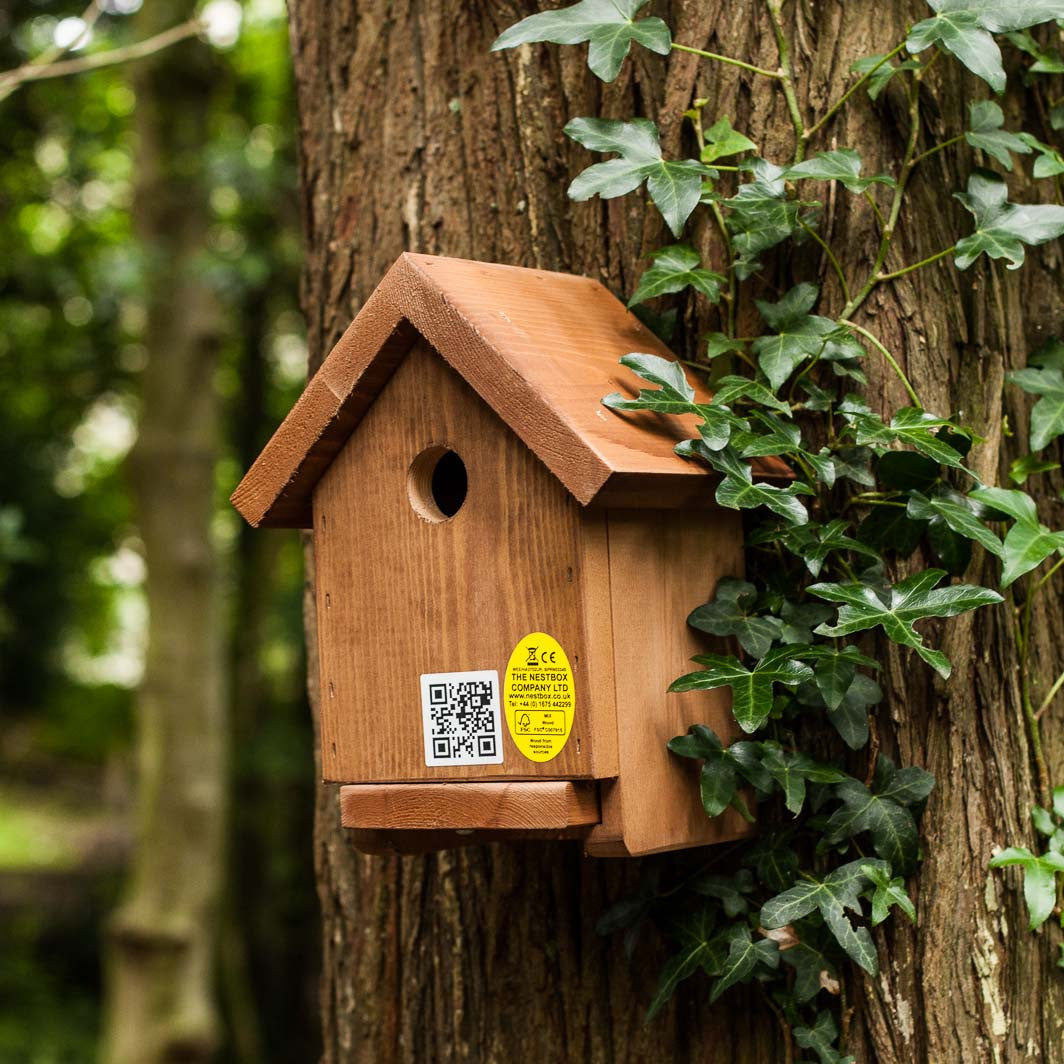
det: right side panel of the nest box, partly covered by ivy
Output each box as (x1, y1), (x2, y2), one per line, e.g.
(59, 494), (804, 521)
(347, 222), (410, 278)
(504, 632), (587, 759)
(587, 510), (751, 857)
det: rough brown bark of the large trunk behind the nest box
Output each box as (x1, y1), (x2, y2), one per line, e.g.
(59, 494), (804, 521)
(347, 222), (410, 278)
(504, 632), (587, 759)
(292, 0), (1064, 1064)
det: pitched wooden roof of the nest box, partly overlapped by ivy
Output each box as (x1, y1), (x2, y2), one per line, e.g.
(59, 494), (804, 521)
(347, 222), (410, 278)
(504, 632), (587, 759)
(232, 253), (727, 528)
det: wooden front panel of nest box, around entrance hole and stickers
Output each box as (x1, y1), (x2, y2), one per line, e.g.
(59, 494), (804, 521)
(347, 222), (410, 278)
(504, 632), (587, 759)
(314, 342), (617, 783)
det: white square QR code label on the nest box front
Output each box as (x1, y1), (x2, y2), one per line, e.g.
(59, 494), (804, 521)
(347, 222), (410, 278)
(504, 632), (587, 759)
(421, 669), (502, 765)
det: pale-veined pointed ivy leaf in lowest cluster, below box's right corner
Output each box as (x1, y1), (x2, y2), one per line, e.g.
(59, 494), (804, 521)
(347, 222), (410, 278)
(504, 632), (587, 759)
(761, 860), (890, 976)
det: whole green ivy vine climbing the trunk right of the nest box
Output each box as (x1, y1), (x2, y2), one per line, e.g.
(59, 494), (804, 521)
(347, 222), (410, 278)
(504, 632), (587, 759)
(493, 0), (1064, 1064)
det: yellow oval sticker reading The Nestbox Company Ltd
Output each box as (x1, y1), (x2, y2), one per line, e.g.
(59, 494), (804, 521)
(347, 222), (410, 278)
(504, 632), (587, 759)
(503, 632), (577, 761)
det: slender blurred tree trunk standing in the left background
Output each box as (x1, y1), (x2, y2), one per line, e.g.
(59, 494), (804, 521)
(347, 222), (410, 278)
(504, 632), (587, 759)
(104, 0), (226, 1064)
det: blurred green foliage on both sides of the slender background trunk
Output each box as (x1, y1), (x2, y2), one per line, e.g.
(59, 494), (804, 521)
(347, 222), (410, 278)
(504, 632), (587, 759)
(0, 0), (318, 1064)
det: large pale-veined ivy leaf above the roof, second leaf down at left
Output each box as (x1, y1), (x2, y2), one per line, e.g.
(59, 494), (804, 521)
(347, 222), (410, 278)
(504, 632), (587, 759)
(565, 118), (714, 236)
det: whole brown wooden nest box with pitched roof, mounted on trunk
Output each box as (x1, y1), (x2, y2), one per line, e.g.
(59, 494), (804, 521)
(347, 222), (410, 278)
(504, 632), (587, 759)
(233, 254), (748, 855)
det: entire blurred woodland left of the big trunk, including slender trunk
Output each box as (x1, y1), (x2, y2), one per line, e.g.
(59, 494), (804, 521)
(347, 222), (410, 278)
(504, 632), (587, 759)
(0, 0), (319, 1064)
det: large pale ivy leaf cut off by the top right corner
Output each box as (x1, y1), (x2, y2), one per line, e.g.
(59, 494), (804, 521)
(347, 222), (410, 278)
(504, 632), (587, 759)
(905, 0), (1064, 93)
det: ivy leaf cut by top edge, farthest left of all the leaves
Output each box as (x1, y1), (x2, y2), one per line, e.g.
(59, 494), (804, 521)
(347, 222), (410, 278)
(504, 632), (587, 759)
(492, 0), (672, 81)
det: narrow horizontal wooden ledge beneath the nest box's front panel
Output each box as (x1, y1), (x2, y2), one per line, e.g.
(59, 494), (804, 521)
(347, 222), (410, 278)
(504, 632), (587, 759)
(339, 780), (599, 831)
